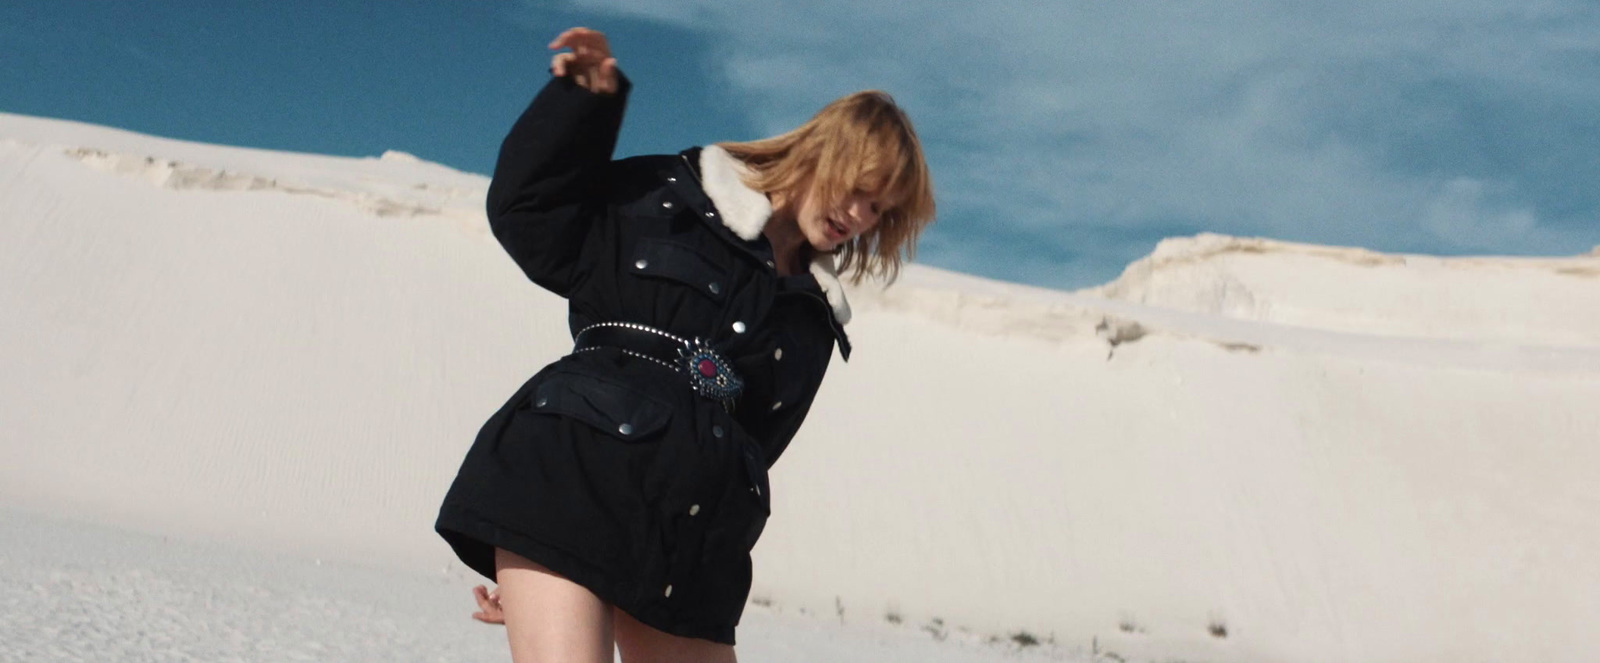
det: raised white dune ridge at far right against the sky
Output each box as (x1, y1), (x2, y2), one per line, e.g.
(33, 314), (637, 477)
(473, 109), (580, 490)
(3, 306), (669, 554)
(1090, 235), (1600, 349)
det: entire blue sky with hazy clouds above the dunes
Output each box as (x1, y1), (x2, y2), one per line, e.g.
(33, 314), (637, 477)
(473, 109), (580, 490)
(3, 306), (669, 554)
(0, 0), (1600, 287)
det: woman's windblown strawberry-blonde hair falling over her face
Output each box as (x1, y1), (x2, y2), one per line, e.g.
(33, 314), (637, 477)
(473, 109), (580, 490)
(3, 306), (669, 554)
(718, 90), (934, 283)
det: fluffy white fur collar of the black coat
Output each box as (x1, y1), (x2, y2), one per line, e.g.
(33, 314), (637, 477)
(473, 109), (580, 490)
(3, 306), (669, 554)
(701, 146), (850, 325)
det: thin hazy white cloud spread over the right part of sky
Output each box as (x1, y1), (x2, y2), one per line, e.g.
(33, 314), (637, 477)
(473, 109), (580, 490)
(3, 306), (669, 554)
(540, 0), (1600, 285)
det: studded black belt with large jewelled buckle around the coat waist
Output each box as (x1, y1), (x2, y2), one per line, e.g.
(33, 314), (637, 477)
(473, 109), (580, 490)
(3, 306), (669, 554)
(573, 322), (744, 413)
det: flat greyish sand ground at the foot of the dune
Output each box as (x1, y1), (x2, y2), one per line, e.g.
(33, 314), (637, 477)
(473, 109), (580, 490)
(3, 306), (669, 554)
(0, 509), (1091, 663)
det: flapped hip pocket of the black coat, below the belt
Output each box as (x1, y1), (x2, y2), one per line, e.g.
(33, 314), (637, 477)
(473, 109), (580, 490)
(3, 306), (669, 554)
(528, 372), (672, 440)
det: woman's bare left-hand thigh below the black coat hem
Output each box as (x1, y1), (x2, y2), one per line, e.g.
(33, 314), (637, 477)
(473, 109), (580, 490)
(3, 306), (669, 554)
(494, 548), (616, 663)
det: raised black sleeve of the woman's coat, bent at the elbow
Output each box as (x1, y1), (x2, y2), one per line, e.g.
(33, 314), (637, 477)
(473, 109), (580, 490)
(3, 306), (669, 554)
(486, 72), (632, 296)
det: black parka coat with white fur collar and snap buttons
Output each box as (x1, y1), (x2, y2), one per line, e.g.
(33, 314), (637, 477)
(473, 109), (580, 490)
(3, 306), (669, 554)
(435, 71), (850, 644)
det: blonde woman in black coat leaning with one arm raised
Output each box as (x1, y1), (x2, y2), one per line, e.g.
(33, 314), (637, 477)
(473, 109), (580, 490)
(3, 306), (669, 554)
(435, 27), (933, 661)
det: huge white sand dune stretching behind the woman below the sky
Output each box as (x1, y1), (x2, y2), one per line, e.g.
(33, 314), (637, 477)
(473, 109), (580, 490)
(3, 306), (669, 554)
(0, 114), (1600, 661)
